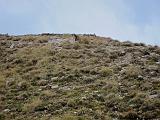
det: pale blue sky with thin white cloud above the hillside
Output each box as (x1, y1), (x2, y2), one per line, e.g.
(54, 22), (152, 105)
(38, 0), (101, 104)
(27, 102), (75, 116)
(0, 0), (160, 45)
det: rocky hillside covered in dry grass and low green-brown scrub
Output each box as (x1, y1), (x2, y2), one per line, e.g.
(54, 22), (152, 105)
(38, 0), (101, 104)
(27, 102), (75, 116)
(0, 34), (160, 120)
